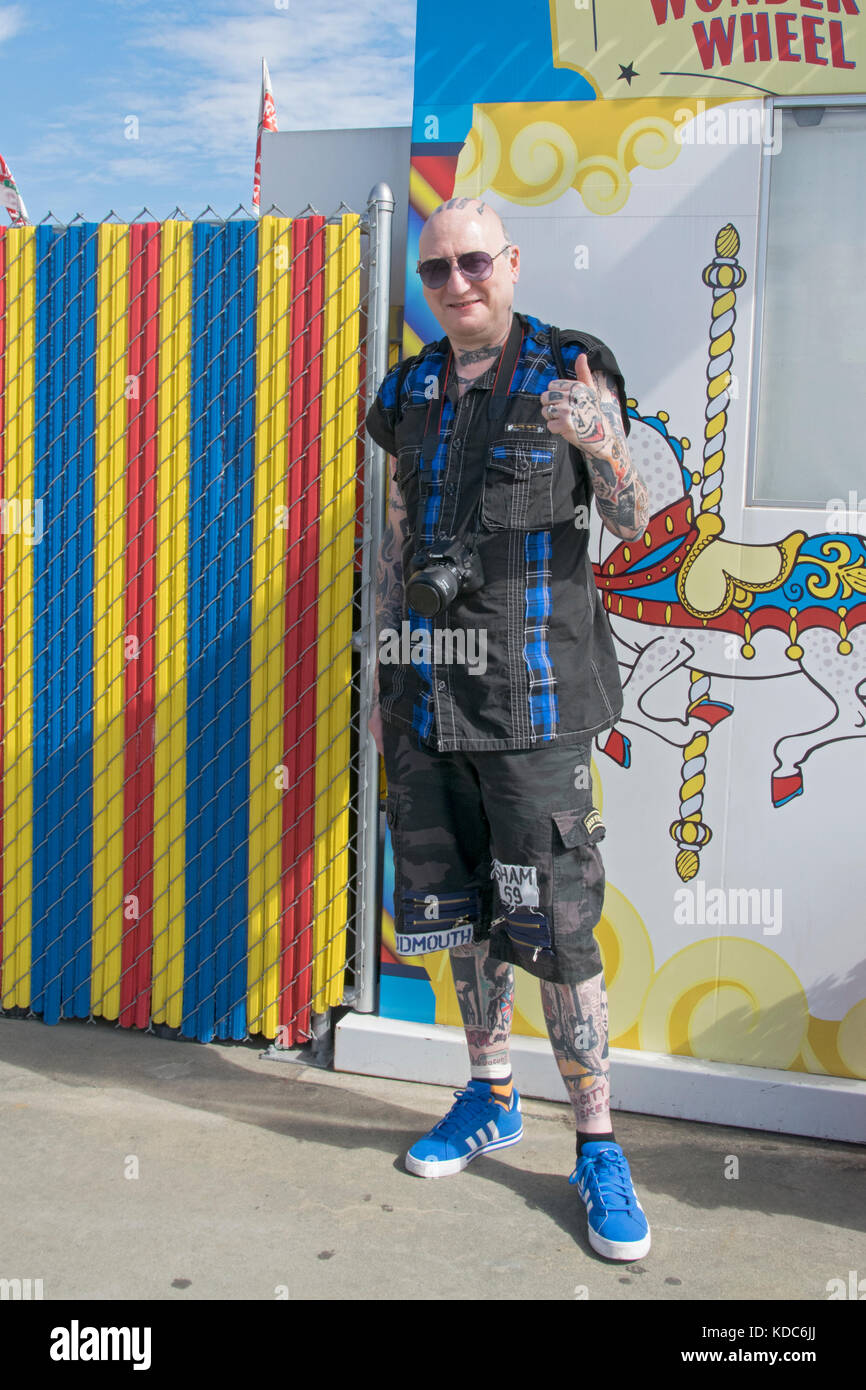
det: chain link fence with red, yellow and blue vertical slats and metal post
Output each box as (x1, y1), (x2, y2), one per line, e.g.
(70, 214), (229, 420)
(0, 185), (392, 1049)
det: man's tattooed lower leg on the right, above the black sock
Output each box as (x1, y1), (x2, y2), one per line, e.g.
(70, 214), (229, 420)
(541, 970), (610, 1134)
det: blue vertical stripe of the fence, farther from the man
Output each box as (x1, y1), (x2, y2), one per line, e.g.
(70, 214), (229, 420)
(32, 222), (99, 1023)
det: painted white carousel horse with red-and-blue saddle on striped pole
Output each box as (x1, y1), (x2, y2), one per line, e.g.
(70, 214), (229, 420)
(594, 225), (866, 881)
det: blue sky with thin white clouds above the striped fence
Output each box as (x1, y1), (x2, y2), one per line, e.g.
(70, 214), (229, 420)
(0, 0), (416, 222)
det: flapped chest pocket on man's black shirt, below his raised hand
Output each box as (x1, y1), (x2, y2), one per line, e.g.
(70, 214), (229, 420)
(481, 431), (556, 531)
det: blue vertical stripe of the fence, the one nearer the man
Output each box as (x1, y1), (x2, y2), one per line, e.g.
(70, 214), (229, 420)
(181, 221), (257, 1041)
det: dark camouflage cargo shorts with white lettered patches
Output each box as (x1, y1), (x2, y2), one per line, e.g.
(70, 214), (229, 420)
(382, 724), (605, 984)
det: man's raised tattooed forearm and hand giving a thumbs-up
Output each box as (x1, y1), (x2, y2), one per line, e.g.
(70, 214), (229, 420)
(541, 354), (649, 541)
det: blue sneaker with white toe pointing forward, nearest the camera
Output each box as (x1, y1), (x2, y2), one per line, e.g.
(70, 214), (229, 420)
(569, 1140), (649, 1259)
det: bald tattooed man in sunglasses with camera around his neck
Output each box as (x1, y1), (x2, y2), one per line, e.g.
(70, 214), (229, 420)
(367, 199), (649, 1259)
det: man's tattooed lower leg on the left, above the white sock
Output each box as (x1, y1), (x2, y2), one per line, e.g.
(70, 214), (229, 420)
(449, 941), (514, 1080)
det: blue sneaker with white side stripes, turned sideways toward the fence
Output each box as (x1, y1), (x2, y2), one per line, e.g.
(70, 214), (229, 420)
(406, 1081), (523, 1177)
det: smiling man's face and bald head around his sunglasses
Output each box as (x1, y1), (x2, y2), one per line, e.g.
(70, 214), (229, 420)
(418, 209), (520, 348)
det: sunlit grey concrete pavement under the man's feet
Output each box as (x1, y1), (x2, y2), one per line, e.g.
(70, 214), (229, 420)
(0, 1017), (866, 1316)
